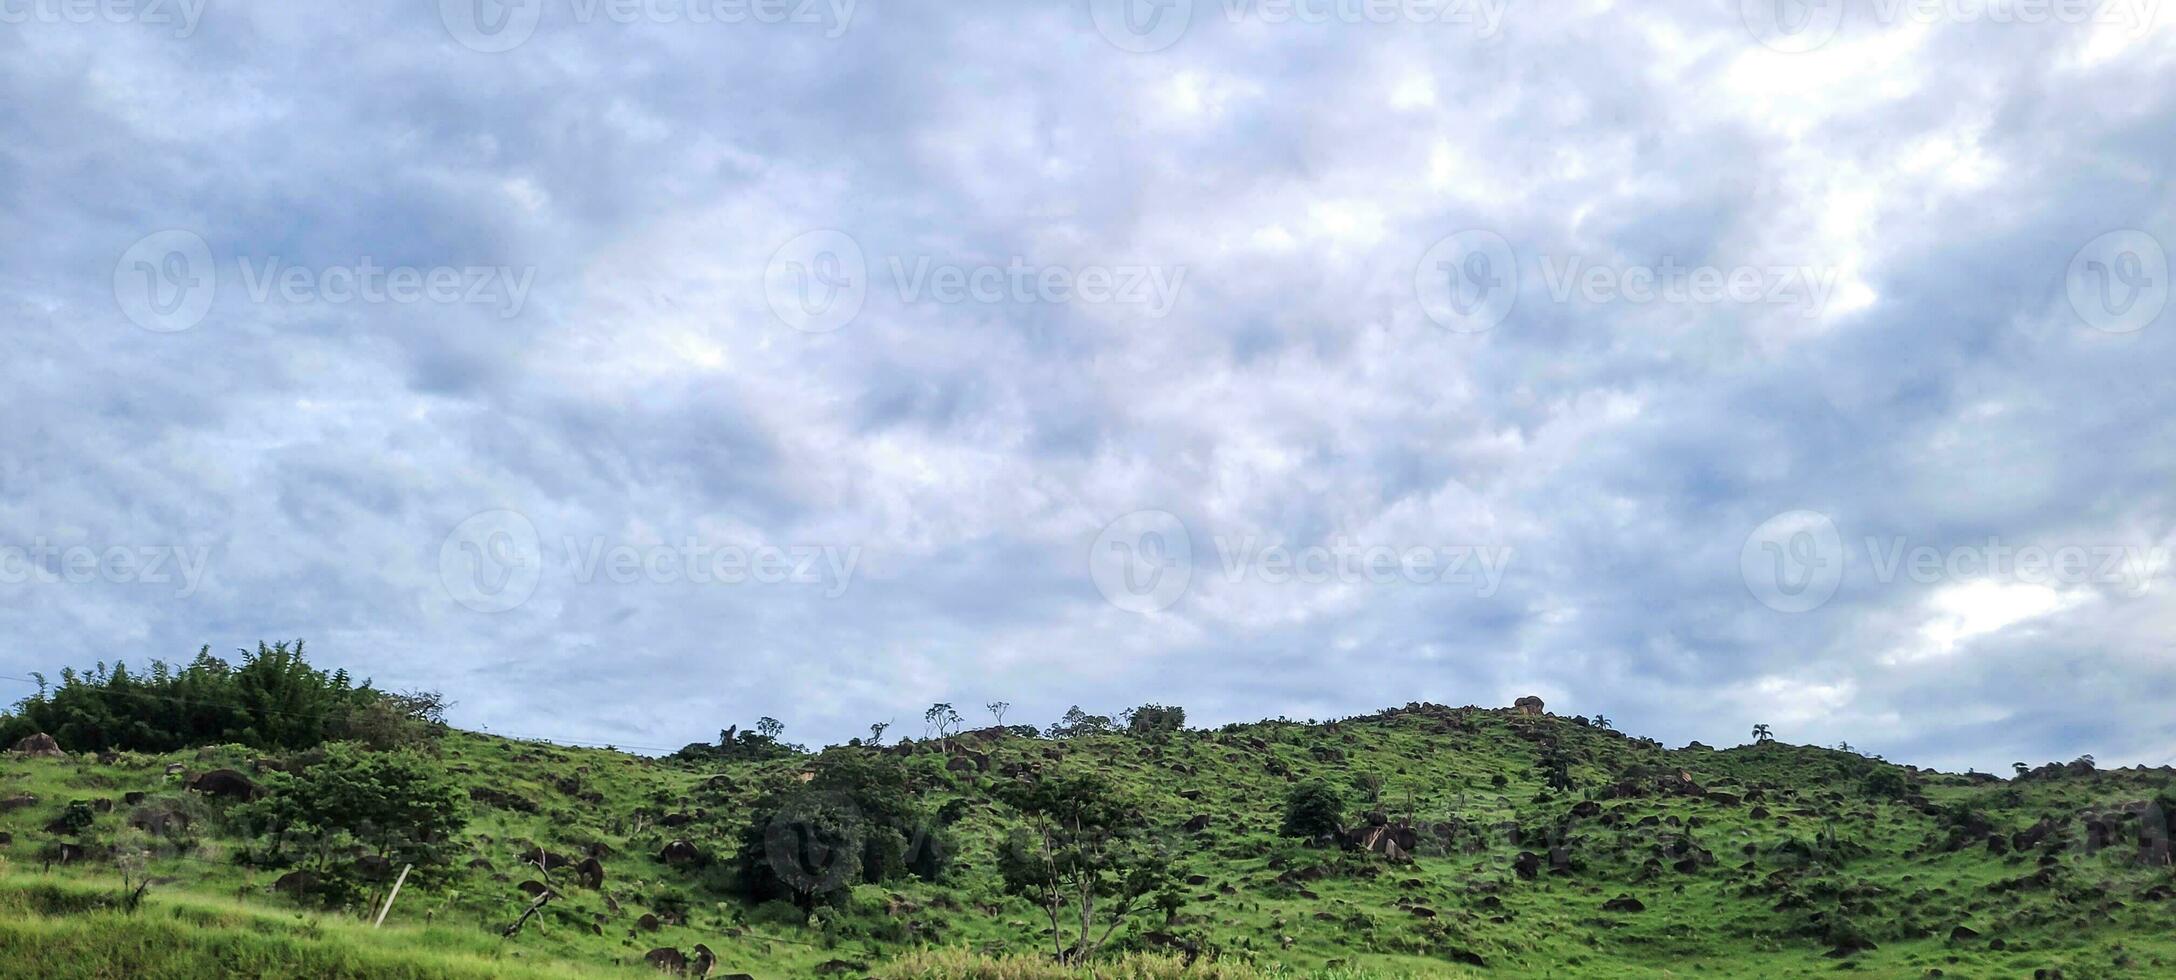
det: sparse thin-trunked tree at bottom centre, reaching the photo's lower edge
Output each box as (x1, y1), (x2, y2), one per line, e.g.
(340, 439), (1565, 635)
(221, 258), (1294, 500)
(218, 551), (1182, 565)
(997, 771), (1184, 963)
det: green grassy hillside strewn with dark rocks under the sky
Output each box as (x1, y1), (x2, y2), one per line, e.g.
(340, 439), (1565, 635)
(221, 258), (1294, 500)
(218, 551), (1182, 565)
(0, 706), (2176, 978)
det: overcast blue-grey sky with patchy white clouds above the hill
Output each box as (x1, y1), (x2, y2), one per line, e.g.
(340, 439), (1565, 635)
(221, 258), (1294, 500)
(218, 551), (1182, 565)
(0, 0), (2176, 769)
